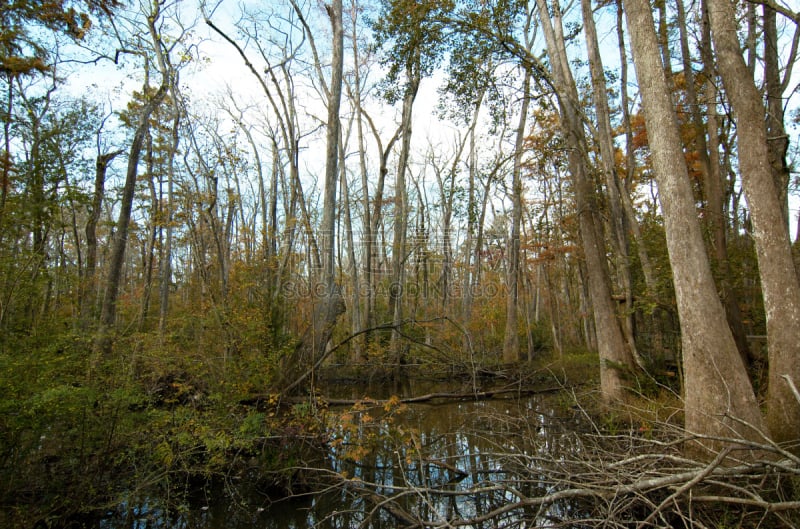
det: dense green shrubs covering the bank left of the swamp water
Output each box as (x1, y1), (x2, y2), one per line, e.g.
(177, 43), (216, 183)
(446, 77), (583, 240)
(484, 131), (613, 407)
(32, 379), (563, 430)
(0, 324), (321, 528)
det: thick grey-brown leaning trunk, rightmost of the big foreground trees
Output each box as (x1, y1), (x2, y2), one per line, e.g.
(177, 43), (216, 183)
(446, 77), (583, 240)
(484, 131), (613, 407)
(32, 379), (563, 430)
(708, 0), (800, 442)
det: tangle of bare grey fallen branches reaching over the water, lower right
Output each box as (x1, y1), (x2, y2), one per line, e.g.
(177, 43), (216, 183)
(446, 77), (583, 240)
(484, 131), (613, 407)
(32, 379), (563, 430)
(310, 398), (800, 529)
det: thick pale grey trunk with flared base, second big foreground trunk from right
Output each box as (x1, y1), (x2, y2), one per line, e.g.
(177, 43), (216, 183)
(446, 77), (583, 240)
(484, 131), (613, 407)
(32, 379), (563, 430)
(625, 0), (763, 450)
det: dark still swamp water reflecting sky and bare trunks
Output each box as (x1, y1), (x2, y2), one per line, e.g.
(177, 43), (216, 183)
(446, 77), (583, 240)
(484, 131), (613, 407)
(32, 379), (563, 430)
(94, 382), (585, 529)
